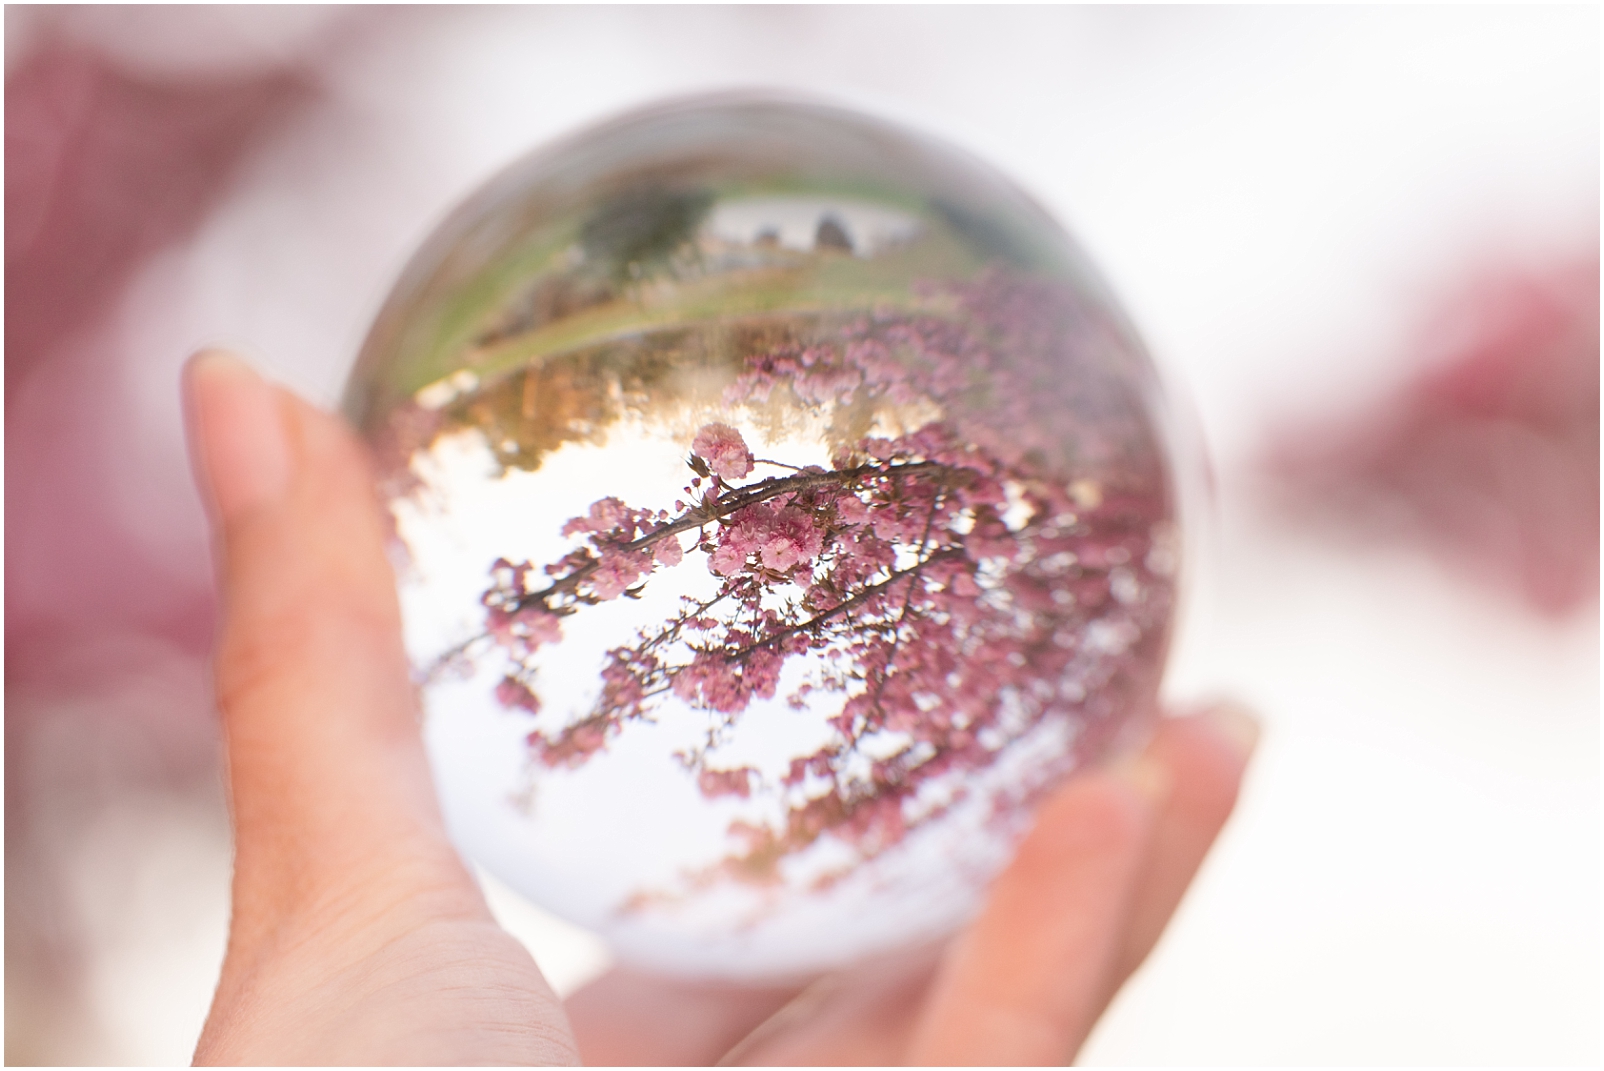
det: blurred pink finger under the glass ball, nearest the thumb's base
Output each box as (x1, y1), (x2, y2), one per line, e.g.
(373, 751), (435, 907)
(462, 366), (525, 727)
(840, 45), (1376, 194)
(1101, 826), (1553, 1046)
(566, 968), (800, 1066)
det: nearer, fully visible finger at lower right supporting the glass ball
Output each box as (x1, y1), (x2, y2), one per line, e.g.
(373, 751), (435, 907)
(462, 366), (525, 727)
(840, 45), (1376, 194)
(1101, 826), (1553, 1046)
(908, 757), (1168, 1065)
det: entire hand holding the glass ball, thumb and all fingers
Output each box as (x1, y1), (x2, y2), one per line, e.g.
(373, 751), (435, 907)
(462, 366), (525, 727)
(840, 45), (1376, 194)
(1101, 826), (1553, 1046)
(184, 351), (1256, 1065)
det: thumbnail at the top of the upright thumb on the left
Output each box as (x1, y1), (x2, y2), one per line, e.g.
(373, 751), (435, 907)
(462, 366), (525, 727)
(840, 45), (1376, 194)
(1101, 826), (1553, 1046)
(184, 350), (292, 524)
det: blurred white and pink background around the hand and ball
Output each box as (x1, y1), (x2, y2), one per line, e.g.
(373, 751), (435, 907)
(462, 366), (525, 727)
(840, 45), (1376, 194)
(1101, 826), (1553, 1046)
(5, 6), (1599, 1063)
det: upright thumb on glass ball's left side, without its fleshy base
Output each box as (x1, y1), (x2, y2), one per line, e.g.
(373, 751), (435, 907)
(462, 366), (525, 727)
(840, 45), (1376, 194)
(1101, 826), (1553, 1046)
(186, 353), (484, 943)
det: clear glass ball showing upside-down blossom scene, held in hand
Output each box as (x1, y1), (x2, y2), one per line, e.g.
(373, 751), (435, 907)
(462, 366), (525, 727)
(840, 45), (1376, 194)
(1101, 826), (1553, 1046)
(346, 96), (1179, 978)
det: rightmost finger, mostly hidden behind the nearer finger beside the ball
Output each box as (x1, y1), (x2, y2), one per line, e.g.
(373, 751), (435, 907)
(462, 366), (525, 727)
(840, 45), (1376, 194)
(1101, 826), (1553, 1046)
(1108, 704), (1259, 999)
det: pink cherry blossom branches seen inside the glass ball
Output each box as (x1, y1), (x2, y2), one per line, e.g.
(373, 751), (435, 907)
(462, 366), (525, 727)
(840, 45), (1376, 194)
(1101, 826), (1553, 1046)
(471, 273), (1169, 880)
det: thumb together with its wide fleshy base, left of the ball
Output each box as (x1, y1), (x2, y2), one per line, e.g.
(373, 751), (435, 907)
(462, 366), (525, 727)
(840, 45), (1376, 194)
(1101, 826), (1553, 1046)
(184, 353), (577, 1065)
